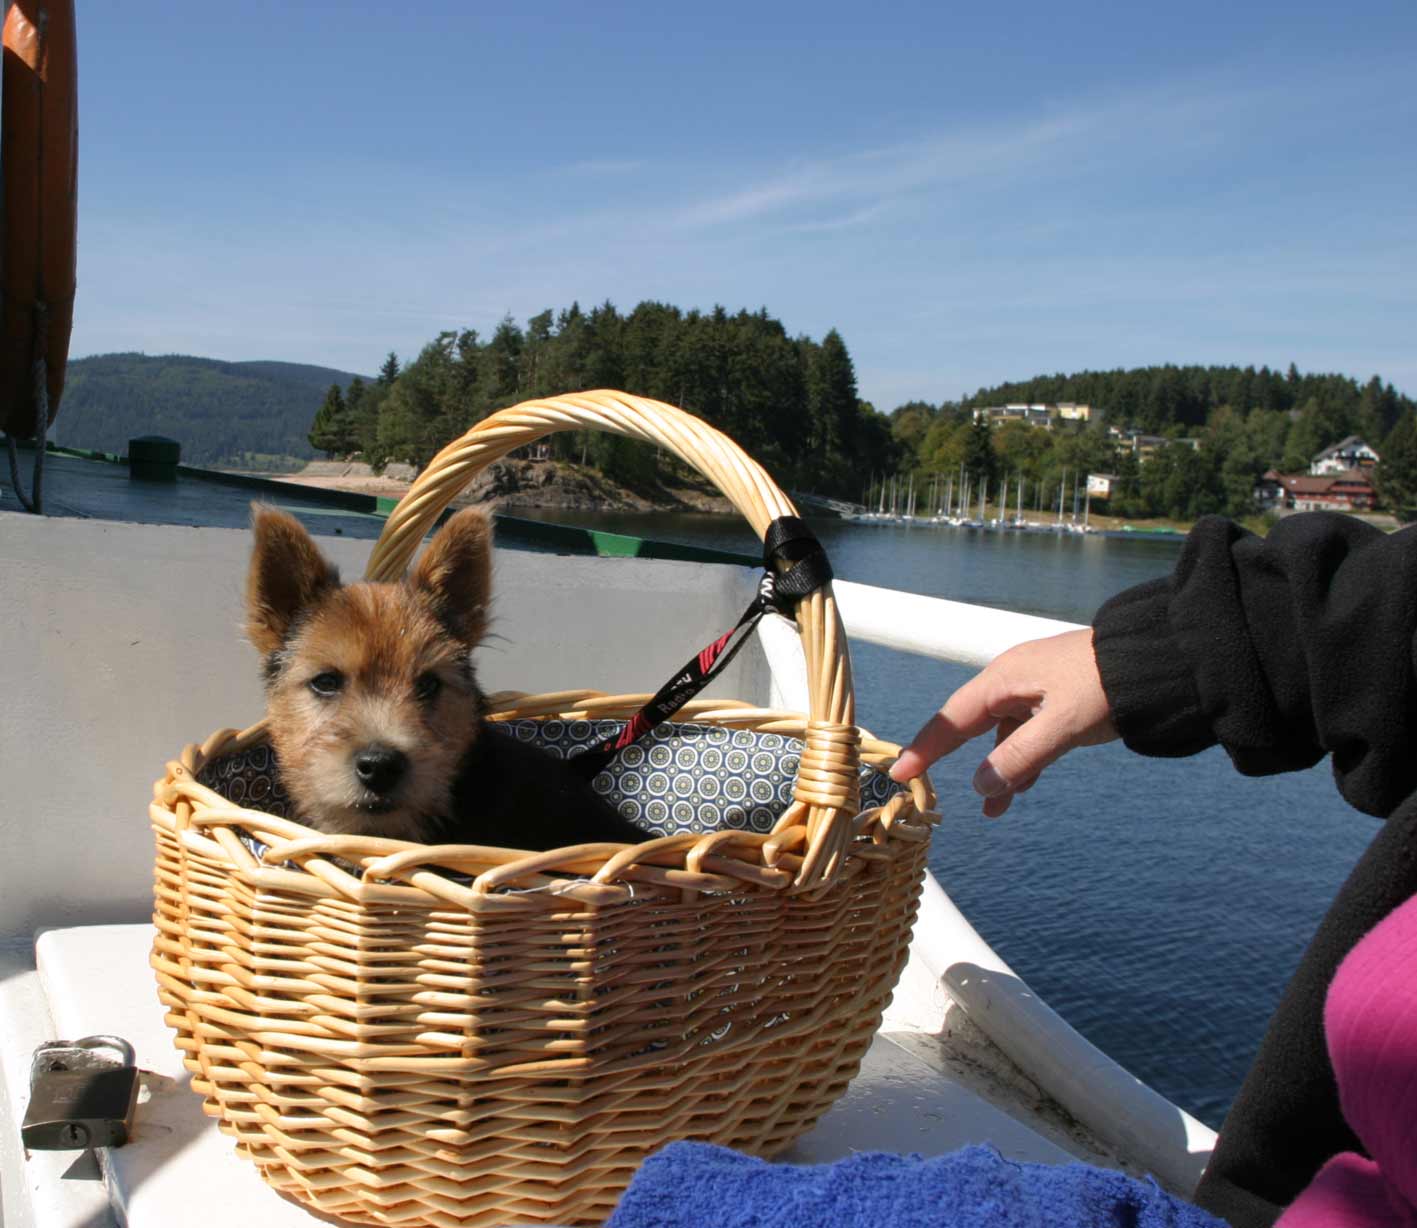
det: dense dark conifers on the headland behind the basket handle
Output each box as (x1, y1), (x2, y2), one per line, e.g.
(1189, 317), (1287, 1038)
(310, 302), (900, 496)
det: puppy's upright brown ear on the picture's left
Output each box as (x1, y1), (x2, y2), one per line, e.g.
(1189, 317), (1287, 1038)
(247, 503), (340, 656)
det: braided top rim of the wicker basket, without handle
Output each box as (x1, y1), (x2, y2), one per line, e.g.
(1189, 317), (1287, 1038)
(150, 691), (938, 908)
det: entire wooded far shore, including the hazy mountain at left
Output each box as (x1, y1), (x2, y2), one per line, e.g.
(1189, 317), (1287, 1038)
(57, 302), (1417, 527)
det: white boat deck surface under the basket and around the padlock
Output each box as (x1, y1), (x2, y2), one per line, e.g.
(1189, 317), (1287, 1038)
(0, 925), (1073, 1228)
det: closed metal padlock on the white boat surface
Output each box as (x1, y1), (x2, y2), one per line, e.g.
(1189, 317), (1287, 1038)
(20, 1035), (137, 1152)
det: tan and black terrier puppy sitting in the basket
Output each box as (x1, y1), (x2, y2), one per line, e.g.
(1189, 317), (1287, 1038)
(247, 504), (648, 850)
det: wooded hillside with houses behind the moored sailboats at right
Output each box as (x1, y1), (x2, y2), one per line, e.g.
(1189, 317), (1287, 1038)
(891, 365), (1417, 520)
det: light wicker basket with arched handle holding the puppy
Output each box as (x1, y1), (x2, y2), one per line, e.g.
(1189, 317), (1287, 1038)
(150, 392), (935, 1228)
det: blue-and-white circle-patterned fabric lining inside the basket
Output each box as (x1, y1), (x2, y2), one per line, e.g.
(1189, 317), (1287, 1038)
(197, 720), (901, 836)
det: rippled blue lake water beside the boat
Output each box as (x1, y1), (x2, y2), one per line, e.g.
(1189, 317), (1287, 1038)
(517, 511), (1377, 1126)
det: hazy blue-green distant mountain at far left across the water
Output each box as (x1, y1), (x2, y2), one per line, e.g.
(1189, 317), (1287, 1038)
(52, 354), (368, 469)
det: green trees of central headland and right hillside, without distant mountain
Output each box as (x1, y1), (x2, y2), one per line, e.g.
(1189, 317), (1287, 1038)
(309, 302), (1417, 527)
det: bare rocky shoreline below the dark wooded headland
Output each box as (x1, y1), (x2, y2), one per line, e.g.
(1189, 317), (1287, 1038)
(281, 457), (733, 514)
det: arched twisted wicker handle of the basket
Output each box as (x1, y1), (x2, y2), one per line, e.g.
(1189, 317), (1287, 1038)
(364, 390), (860, 889)
